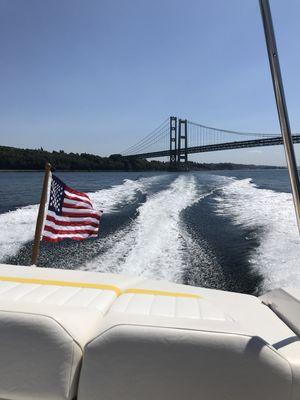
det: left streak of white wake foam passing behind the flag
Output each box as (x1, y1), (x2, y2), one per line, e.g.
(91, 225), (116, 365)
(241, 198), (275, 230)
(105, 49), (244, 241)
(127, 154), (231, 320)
(0, 176), (160, 262)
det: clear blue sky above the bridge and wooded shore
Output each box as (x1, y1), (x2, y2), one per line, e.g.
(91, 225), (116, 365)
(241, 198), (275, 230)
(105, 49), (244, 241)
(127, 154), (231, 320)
(0, 0), (300, 164)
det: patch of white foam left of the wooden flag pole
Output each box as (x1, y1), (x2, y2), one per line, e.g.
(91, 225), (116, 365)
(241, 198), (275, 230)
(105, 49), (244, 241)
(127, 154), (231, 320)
(0, 205), (38, 261)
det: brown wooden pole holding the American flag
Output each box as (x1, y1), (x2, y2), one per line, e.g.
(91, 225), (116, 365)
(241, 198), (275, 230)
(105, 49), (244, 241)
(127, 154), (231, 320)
(31, 163), (51, 265)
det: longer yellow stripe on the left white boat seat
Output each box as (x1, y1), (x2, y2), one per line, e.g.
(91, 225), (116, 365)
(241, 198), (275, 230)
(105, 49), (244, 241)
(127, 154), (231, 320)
(0, 276), (122, 296)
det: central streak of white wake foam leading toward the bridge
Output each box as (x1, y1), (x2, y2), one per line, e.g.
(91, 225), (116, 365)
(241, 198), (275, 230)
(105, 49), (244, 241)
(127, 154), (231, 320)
(86, 175), (199, 282)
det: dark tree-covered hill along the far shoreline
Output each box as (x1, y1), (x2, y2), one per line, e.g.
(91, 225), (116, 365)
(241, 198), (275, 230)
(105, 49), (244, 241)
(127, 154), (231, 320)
(0, 146), (282, 171)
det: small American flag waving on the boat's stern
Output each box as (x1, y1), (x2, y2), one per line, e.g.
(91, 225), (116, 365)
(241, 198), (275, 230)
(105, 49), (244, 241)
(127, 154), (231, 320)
(42, 175), (102, 242)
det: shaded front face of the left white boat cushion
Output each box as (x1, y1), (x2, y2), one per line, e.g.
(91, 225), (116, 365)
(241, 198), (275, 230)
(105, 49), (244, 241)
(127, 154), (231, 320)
(0, 311), (82, 400)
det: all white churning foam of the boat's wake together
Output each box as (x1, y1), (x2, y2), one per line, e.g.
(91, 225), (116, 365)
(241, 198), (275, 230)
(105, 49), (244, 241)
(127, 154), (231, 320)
(0, 174), (300, 290)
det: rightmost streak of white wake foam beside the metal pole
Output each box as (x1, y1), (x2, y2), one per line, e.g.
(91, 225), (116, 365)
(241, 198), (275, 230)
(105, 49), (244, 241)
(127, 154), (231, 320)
(217, 179), (300, 290)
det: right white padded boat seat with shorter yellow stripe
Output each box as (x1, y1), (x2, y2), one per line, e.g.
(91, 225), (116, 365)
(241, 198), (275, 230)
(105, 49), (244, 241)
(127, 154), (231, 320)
(78, 280), (300, 400)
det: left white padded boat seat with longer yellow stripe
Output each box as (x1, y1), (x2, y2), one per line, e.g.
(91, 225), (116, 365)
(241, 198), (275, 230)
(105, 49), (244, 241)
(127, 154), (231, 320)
(0, 265), (142, 400)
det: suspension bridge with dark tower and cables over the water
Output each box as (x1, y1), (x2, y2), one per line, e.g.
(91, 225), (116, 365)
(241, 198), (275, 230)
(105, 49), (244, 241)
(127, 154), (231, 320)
(121, 117), (300, 167)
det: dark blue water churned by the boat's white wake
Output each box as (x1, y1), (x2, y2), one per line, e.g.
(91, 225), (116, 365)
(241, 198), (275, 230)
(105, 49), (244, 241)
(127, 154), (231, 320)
(0, 170), (300, 294)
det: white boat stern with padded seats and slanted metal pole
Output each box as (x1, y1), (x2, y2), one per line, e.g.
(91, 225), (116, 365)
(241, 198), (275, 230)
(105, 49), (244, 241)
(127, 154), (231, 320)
(0, 0), (300, 400)
